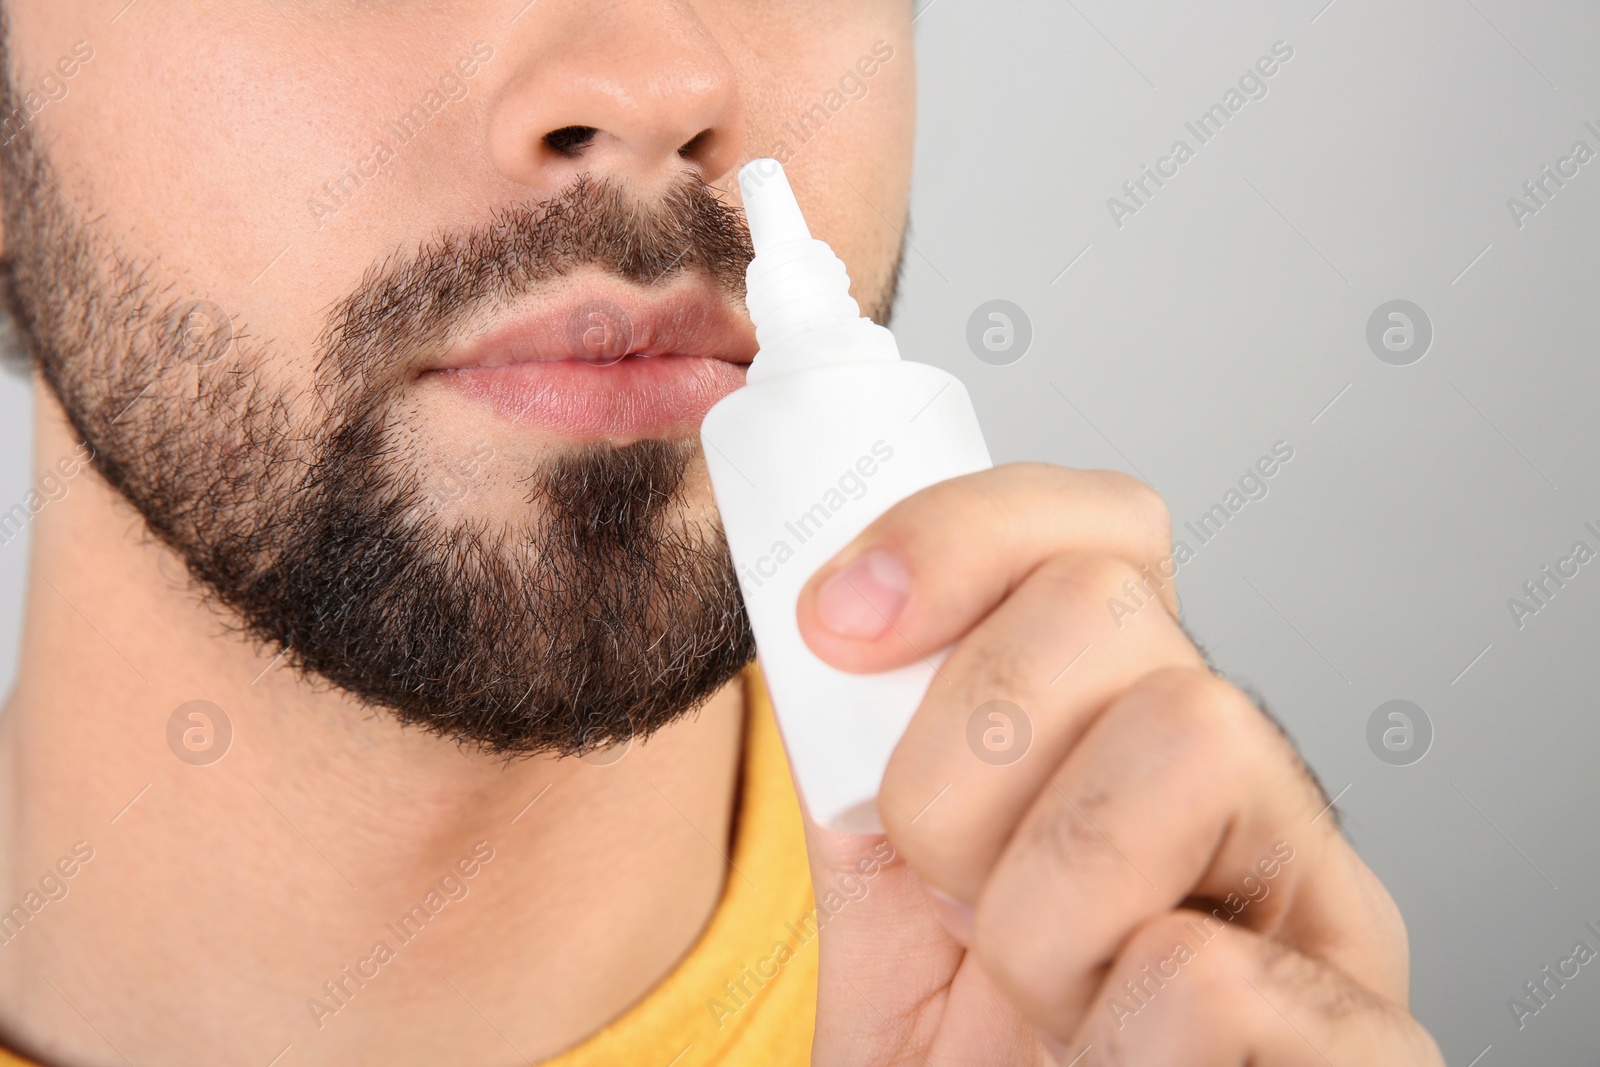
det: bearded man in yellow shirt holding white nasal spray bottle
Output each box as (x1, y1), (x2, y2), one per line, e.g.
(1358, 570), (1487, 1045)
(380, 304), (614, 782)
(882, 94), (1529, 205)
(0, 0), (1442, 1067)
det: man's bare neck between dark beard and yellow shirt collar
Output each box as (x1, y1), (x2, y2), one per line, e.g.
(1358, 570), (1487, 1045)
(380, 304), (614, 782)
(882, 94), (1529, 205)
(0, 386), (742, 1067)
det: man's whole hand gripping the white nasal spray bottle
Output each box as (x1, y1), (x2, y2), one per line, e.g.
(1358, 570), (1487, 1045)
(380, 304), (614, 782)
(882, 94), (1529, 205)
(798, 464), (1443, 1067)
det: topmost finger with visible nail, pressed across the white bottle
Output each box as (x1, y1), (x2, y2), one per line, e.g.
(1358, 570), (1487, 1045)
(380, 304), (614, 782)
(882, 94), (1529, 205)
(797, 464), (1176, 672)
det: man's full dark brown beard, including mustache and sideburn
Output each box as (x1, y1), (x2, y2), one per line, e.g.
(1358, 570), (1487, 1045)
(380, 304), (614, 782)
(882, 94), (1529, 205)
(0, 51), (754, 755)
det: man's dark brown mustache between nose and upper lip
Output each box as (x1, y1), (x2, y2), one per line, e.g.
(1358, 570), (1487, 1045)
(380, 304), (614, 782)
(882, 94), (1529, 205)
(318, 174), (755, 386)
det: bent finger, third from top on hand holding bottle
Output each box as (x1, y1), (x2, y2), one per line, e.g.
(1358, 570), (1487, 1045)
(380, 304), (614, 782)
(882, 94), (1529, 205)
(973, 670), (1334, 1029)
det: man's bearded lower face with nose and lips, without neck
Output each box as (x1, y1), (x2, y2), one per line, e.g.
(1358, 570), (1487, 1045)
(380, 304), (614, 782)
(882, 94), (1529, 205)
(0, 0), (914, 753)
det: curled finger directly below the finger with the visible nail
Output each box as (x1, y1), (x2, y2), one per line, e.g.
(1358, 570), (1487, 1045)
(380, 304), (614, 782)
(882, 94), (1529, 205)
(878, 555), (1202, 904)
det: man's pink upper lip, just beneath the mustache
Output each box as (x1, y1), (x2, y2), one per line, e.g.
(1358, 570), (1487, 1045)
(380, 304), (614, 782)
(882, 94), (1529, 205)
(427, 282), (757, 371)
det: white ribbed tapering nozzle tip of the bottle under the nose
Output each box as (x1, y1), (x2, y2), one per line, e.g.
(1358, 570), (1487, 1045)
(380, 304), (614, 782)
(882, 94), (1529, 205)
(739, 158), (899, 381)
